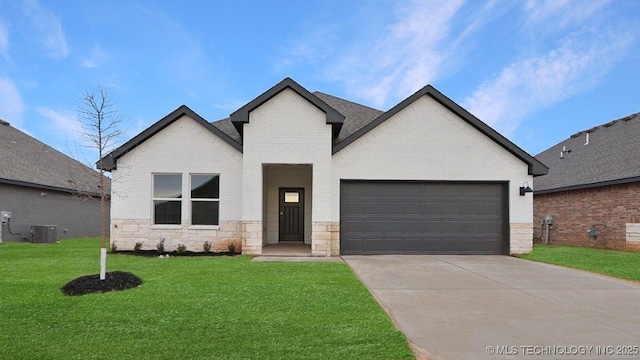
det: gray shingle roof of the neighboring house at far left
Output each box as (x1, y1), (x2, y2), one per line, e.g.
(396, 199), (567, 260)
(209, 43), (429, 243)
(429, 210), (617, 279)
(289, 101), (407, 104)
(0, 121), (110, 195)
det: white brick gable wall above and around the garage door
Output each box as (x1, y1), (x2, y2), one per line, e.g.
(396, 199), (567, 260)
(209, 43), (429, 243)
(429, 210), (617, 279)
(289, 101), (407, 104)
(331, 96), (533, 253)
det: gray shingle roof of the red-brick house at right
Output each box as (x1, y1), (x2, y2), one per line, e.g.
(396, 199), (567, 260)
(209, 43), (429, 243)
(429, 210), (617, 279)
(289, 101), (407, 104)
(533, 113), (640, 193)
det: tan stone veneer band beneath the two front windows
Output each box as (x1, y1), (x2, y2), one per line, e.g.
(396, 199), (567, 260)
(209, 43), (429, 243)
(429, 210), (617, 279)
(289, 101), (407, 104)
(111, 219), (244, 252)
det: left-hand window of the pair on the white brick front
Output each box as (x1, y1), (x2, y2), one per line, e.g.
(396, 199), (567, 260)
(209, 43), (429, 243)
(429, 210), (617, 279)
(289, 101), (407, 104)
(153, 174), (182, 225)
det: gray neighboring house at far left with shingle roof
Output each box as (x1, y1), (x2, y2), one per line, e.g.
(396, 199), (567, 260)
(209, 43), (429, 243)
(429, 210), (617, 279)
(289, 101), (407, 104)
(0, 120), (109, 240)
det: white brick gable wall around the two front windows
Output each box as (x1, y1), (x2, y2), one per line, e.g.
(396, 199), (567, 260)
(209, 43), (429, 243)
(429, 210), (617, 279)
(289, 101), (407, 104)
(111, 116), (242, 248)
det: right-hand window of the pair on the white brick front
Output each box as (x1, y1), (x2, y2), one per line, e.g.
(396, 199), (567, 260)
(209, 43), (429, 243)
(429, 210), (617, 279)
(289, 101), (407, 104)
(191, 174), (220, 225)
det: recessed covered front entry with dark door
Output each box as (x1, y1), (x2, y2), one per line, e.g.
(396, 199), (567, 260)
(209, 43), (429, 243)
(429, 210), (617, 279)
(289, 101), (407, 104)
(262, 164), (313, 246)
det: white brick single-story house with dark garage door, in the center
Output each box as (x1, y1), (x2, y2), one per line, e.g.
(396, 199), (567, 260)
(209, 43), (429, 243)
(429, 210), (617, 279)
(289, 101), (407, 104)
(103, 78), (547, 256)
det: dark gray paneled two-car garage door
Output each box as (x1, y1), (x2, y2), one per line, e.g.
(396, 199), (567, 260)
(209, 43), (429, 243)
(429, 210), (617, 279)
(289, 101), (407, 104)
(340, 180), (508, 255)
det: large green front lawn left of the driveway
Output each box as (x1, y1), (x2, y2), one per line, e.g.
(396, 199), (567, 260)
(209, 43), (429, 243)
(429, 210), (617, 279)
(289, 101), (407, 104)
(0, 239), (412, 360)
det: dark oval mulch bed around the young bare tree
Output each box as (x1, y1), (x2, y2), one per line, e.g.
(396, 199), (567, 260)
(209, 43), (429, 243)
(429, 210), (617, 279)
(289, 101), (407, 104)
(61, 271), (142, 296)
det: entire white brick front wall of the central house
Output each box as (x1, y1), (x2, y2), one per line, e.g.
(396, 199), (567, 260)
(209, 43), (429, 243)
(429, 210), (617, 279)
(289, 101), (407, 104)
(111, 89), (533, 254)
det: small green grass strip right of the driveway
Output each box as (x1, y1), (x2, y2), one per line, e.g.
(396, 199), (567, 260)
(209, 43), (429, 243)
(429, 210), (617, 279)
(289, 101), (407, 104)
(519, 245), (640, 281)
